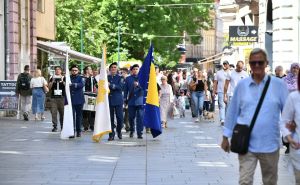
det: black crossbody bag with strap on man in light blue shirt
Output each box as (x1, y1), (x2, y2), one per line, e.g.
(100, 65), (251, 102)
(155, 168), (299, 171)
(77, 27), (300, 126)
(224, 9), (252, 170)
(230, 76), (271, 155)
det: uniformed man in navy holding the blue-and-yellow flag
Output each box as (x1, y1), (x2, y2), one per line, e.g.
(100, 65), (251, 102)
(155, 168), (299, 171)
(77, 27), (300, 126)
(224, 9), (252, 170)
(124, 64), (144, 139)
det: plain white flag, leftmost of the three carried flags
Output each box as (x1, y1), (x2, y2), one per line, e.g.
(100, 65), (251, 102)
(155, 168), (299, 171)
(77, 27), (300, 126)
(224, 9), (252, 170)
(60, 52), (74, 139)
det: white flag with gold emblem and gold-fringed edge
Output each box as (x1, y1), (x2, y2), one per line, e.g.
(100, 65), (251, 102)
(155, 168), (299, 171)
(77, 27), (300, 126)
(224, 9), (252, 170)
(93, 46), (111, 142)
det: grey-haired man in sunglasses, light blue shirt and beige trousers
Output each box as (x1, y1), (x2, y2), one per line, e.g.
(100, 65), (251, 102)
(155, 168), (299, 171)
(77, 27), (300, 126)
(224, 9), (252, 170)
(221, 48), (288, 185)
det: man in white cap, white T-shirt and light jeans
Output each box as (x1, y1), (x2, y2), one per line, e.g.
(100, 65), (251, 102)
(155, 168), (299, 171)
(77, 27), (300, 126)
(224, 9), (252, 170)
(213, 60), (230, 126)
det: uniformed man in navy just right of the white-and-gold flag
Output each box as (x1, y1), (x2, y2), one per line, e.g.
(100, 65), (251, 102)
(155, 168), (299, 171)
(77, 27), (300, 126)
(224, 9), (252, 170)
(107, 62), (124, 141)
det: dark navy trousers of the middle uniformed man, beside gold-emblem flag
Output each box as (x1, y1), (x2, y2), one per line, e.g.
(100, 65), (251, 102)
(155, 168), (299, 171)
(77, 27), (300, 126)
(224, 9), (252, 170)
(109, 105), (123, 136)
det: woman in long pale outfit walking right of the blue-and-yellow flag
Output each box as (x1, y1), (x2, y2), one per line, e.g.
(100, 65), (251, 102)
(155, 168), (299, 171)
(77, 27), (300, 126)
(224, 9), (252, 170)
(159, 76), (174, 128)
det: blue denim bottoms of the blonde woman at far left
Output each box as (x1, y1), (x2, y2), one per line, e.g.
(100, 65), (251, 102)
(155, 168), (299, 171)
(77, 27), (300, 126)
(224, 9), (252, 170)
(32, 87), (45, 114)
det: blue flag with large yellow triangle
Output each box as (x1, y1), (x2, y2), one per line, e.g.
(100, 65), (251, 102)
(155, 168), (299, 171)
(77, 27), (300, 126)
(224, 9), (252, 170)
(138, 45), (162, 138)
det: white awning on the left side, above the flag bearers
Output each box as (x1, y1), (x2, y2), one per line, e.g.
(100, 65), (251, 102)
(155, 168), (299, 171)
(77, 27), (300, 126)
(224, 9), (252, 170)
(37, 41), (101, 63)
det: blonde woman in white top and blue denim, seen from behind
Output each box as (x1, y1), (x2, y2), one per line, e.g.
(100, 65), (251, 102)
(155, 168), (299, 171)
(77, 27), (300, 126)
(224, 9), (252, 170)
(30, 69), (48, 120)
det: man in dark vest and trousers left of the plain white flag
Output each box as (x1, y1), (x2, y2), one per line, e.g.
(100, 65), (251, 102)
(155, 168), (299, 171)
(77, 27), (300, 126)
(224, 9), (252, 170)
(49, 66), (66, 132)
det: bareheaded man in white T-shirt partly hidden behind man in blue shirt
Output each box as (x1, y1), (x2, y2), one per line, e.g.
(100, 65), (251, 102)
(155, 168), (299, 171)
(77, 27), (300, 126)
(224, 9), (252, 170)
(224, 60), (249, 106)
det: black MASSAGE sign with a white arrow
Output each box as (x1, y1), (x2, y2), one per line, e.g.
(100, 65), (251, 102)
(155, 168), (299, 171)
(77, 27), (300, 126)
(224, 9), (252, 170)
(229, 26), (258, 42)
